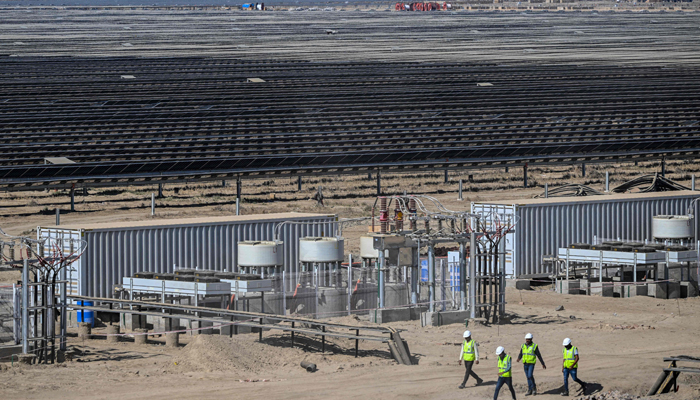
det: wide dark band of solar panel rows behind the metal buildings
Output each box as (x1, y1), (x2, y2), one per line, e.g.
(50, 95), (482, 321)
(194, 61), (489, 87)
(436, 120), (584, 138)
(0, 57), (700, 190)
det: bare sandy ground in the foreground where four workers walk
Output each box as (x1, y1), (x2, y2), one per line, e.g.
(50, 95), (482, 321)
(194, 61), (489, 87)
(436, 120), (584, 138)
(0, 289), (700, 400)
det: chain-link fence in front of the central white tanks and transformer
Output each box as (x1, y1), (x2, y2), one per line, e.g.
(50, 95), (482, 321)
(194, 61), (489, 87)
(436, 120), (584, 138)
(233, 258), (461, 318)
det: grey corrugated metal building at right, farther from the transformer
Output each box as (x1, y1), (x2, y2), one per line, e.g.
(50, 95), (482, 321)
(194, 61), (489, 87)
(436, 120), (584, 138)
(471, 191), (700, 277)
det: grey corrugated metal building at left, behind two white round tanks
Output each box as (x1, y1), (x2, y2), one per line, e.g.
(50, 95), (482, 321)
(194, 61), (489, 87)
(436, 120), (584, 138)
(37, 213), (338, 297)
